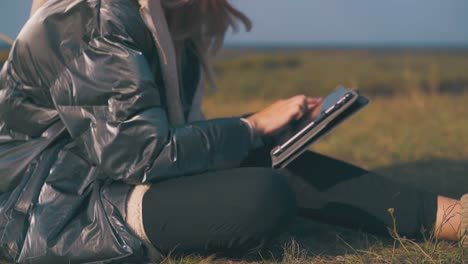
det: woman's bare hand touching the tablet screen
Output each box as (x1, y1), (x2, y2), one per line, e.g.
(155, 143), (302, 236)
(247, 95), (322, 136)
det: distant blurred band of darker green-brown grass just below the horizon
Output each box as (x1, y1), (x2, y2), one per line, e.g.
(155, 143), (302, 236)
(210, 50), (468, 100)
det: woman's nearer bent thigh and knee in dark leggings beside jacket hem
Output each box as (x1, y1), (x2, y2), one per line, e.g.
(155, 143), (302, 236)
(143, 168), (295, 255)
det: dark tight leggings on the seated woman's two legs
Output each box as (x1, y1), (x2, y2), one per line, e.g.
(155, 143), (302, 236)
(143, 149), (437, 255)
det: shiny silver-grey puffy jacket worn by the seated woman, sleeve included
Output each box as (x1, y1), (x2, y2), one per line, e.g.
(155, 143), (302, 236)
(0, 0), (252, 263)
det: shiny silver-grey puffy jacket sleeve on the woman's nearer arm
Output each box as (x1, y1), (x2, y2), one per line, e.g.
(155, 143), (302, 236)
(51, 36), (252, 184)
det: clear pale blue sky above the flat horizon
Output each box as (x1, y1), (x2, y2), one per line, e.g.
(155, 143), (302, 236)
(0, 0), (468, 47)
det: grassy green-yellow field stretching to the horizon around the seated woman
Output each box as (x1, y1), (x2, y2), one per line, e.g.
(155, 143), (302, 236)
(0, 49), (468, 264)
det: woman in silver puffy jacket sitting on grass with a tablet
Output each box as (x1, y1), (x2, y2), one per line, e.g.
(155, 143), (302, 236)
(0, 0), (467, 263)
